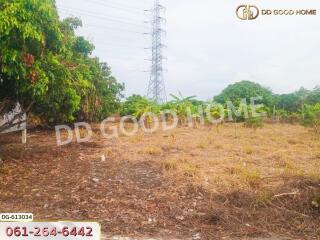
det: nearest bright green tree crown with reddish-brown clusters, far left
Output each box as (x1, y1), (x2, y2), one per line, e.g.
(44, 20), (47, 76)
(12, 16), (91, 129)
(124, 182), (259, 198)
(0, 0), (63, 112)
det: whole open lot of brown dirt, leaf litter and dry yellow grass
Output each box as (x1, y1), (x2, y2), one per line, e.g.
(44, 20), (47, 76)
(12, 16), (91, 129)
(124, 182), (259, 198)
(0, 124), (320, 240)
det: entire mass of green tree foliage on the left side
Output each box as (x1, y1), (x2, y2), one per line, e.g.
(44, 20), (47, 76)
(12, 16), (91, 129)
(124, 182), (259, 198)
(0, 0), (124, 123)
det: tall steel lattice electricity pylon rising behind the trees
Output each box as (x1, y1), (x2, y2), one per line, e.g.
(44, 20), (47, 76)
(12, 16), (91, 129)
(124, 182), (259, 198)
(148, 0), (167, 103)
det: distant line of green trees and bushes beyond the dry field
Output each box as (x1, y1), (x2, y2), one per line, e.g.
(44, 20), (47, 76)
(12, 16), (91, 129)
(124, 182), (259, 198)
(121, 81), (320, 132)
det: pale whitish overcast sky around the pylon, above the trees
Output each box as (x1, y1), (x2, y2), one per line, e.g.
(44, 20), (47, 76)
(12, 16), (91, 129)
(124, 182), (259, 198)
(56, 0), (320, 100)
